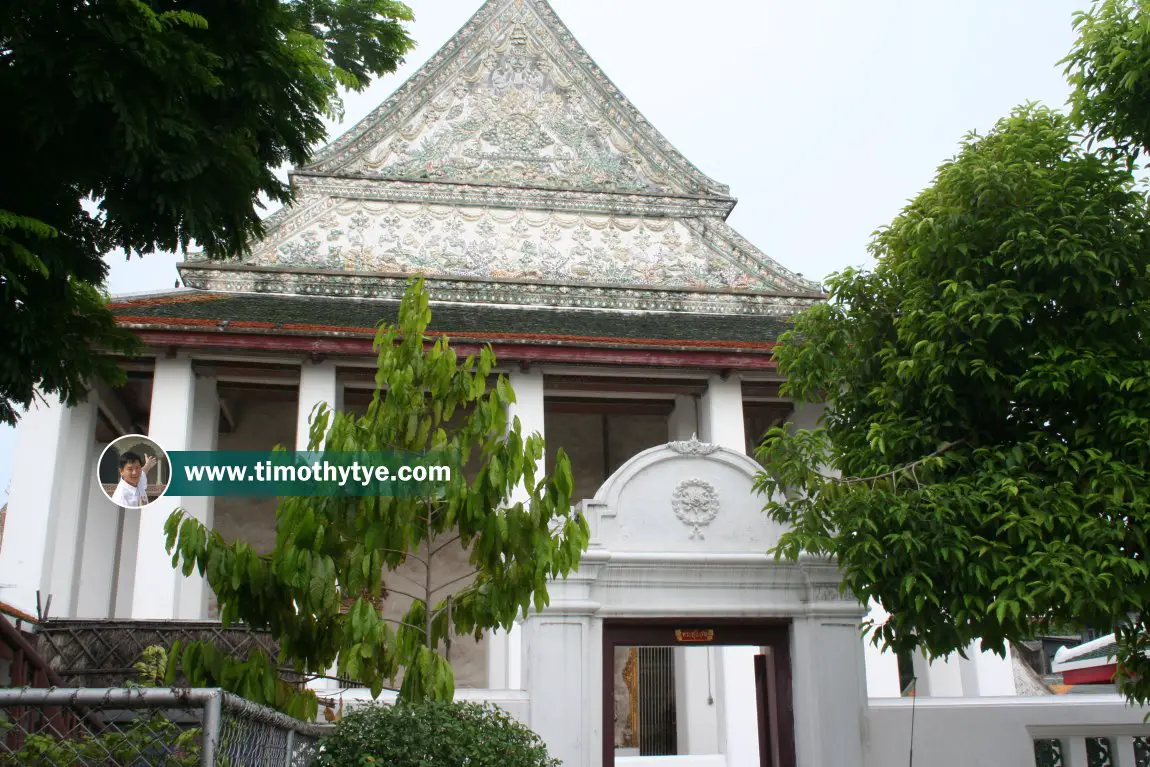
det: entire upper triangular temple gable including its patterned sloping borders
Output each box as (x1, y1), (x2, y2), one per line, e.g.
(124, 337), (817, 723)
(308, 0), (729, 197)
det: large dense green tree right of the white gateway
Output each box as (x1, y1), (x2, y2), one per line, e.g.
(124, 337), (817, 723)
(758, 106), (1150, 700)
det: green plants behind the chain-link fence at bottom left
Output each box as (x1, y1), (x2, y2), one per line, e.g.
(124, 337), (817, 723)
(0, 712), (201, 767)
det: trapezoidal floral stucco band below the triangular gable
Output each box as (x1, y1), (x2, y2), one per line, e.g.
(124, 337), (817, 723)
(259, 200), (780, 290)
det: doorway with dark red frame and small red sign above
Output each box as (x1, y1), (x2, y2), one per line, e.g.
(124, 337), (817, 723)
(603, 618), (796, 767)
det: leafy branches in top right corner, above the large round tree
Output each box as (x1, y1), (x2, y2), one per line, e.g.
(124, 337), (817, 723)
(1061, 0), (1150, 159)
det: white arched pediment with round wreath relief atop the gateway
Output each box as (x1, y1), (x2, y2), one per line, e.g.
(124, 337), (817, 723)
(583, 438), (784, 553)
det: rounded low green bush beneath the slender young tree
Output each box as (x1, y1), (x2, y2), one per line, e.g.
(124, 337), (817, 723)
(316, 701), (559, 767)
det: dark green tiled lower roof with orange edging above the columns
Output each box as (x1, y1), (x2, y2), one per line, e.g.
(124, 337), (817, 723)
(112, 292), (788, 352)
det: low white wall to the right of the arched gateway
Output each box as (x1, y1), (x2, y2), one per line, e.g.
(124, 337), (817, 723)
(865, 695), (1150, 767)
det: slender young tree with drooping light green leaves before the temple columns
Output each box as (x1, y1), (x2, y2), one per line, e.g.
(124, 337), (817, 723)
(167, 282), (589, 718)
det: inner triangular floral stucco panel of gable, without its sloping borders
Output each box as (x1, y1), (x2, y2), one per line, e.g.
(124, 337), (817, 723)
(350, 25), (676, 193)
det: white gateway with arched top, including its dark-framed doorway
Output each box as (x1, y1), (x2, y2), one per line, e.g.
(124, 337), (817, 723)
(522, 440), (866, 767)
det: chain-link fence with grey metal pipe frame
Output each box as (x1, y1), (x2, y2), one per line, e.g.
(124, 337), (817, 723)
(0, 688), (329, 767)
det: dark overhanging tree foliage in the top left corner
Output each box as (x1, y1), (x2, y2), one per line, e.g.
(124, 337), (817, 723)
(0, 0), (412, 423)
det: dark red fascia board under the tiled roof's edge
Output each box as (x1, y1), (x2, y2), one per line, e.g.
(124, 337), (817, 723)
(136, 330), (775, 370)
